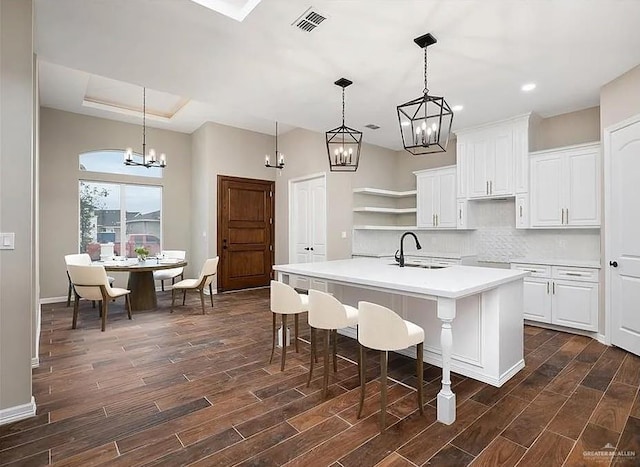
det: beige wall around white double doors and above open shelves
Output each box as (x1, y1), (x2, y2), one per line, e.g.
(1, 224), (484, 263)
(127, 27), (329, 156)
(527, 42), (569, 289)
(275, 128), (396, 264)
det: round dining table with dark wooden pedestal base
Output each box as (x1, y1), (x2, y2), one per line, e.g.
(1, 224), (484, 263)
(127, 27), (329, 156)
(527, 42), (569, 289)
(101, 258), (187, 311)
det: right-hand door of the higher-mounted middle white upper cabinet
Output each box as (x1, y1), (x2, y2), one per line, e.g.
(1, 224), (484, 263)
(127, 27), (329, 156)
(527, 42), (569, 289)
(487, 126), (513, 196)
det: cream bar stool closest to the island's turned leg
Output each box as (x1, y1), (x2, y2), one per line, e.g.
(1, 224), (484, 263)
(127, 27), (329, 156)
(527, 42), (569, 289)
(358, 302), (424, 431)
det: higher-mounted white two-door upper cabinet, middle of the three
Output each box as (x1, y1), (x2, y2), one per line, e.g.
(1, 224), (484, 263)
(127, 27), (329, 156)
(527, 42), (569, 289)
(456, 114), (531, 199)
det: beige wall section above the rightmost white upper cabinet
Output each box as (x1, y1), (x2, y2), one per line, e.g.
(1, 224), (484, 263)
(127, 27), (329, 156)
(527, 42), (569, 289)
(534, 107), (600, 150)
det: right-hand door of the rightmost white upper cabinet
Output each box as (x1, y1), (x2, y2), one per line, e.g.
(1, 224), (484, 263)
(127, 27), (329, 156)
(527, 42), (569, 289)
(564, 150), (600, 226)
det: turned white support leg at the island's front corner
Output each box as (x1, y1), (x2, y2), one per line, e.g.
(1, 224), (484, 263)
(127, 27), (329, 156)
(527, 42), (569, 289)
(438, 298), (456, 425)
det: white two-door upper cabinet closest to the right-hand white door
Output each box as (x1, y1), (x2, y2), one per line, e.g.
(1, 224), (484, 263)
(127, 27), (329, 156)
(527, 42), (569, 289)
(530, 143), (600, 227)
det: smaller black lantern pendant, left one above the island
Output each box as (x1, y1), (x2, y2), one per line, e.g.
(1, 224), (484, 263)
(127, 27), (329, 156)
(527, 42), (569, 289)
(326, 78), (362, 172)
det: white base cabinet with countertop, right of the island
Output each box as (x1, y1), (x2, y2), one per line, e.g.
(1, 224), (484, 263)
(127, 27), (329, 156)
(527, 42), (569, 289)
(511, 263), (599, 331)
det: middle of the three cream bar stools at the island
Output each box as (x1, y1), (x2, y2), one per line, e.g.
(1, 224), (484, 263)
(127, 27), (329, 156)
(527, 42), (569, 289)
(307, 290), (358, 398)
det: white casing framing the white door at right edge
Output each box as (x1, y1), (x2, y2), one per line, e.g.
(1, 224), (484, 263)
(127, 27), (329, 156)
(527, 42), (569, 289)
(602, 114), (640, 345)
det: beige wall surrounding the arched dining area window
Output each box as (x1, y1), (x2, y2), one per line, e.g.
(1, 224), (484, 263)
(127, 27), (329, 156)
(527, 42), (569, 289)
(39, 108), (191, 299)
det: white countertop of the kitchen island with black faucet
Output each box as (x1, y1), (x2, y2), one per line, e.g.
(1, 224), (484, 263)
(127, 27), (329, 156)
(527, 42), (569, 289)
(273, 258), (530, 298)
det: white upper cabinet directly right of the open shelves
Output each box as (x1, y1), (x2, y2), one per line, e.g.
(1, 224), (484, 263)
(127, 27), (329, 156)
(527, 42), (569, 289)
(414, 167), (458, 229)
